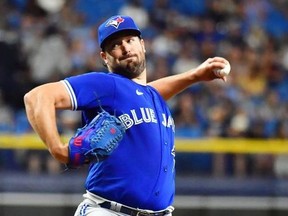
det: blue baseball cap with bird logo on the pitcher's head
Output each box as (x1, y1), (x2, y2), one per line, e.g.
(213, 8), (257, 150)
(98, 15), (141, 49)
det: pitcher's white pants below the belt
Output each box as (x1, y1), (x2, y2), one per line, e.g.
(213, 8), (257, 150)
(74, 192), (174, 216)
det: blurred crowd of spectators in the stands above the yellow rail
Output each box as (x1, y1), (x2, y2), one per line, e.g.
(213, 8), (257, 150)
(0, 0), (288, 177)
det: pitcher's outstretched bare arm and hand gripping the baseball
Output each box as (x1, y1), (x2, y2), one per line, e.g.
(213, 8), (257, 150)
(148, 57), (227, 100)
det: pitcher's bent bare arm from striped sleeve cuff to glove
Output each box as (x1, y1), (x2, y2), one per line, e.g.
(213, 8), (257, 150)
(24, 82), (71, 163)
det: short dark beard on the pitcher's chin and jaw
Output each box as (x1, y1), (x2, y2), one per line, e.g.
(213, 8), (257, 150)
(111, 57), (146, 79)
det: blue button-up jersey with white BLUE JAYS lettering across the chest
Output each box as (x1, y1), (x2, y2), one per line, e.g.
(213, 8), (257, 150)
(64, 72), (175, 211)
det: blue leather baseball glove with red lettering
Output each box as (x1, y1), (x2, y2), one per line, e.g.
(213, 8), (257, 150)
(67, 111), (126, 168)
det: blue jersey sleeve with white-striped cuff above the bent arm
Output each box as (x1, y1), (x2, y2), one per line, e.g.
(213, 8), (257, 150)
(62, 72), (115, 110)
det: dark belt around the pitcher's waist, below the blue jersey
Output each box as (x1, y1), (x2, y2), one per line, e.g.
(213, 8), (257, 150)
(99, 201), (170, 216)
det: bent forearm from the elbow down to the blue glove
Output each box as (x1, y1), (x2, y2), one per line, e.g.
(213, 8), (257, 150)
(24, 84), (68, 163)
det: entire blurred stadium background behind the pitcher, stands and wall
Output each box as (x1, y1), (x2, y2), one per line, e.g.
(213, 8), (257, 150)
(0, 0), (288, 216)
